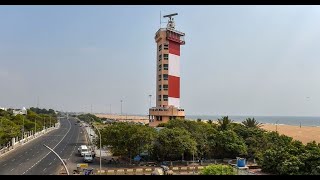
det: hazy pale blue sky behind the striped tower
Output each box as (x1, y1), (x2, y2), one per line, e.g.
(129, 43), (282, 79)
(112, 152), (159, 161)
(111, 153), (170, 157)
(0, 5), (320, 116)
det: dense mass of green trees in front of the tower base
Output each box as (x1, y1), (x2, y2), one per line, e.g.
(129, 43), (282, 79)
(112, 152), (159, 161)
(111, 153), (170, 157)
(79, 116), (320, 175)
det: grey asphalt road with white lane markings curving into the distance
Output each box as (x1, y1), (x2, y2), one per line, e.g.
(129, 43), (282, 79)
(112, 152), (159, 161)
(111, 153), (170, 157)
(0, 118), (87, 175)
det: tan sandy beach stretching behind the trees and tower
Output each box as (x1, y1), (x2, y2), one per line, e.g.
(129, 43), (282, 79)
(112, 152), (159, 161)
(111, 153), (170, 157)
(95, 114), (320, 144)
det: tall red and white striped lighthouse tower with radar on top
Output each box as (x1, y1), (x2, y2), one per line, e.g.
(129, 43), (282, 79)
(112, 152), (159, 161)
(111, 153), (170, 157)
(149, 13), (185, 126)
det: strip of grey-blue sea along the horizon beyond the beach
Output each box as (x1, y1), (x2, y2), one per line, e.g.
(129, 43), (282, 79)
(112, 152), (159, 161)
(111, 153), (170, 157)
(186, 115), (320, 126)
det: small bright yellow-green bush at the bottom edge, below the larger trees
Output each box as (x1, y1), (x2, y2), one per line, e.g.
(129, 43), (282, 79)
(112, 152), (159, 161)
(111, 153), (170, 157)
(200, 164), (236, 175)
